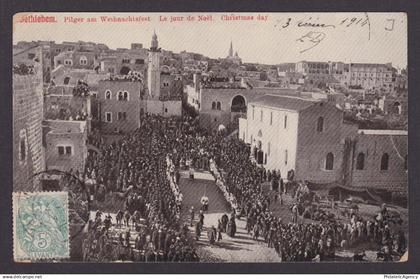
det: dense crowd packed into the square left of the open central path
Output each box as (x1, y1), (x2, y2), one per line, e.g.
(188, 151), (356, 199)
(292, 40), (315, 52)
(83, 116), (202, 262)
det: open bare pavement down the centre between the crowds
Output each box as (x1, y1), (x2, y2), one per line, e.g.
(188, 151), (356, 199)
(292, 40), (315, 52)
(179, 172), (280, 262)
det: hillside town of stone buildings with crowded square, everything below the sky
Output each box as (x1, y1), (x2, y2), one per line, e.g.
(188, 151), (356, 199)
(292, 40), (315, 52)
(12, 32), (408, 262)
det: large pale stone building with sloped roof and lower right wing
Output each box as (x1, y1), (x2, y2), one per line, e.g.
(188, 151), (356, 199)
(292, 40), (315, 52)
(239, 95), (407, 189)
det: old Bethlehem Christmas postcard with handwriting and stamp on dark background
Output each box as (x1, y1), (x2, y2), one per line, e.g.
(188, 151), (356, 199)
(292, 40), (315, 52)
(11, 12), (410, 264)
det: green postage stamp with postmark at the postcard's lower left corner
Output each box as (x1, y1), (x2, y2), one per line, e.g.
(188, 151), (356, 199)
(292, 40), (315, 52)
(13, 192), (70, 261)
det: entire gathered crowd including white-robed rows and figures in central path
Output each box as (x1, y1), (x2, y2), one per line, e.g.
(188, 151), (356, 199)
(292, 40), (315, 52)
(70, 112), (407, 262)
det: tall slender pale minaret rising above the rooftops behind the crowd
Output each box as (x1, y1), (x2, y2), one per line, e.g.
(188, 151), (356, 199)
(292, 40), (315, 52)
(147, 32), (160, 100)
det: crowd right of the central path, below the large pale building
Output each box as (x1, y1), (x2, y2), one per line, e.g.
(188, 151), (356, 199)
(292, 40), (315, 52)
(200, 138), (407, 261)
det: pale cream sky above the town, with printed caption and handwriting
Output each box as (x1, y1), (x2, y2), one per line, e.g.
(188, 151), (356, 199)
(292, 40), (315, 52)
(13, 13), (407, 68)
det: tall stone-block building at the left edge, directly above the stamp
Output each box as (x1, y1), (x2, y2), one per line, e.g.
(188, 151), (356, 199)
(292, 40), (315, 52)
(12, 48), (45, 191)
